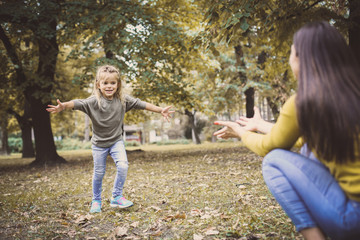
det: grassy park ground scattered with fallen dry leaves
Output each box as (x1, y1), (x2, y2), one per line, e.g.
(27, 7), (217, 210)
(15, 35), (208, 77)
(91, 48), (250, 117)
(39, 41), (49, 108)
(0, 143), (300, 240)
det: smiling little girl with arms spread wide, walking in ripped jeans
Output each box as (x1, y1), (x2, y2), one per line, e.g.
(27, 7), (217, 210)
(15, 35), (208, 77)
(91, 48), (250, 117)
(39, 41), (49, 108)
(46, 65), (175, 213)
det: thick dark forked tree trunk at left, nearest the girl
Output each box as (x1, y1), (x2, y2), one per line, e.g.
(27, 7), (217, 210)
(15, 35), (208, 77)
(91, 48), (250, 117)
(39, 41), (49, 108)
(0, 0), (66, 165)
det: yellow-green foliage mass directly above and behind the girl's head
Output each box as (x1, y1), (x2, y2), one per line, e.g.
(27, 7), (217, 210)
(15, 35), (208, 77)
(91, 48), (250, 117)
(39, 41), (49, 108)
(64, 0), (207, 142)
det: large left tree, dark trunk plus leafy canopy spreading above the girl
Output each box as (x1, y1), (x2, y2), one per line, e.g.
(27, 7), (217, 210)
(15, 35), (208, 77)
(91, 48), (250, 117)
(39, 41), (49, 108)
(0, 0), (211, 157)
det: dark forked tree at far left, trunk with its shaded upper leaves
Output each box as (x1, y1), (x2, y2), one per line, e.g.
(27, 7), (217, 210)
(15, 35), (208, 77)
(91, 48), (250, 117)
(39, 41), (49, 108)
(0, 0), (65, 165)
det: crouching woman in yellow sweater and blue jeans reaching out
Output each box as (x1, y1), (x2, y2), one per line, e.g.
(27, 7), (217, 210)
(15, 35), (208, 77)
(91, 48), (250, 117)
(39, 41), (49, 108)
(214, 22), (360, 239)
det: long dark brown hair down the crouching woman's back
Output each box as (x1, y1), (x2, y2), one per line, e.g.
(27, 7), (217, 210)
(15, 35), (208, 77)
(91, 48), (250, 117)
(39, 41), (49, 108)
(293, 22), (360, 163)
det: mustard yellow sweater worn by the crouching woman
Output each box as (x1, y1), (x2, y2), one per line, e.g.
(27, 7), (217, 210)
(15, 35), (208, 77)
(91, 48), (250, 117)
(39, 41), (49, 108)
(242, 95), (360, 201)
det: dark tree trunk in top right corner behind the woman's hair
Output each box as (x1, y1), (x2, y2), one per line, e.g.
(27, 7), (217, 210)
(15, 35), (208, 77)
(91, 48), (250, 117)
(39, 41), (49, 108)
(349, 0), (360, 64)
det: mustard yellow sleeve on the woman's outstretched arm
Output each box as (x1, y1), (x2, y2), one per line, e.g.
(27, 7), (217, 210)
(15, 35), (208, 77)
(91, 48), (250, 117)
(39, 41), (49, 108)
(242, 95), (300, 156)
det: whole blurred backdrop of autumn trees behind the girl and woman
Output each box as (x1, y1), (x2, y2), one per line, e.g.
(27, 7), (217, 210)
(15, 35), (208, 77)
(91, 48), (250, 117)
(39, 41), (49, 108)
(0, 0), (360, 165)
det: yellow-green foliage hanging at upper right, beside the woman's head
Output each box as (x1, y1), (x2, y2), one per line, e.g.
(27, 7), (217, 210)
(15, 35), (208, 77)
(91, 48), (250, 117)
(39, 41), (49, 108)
(194, 0), (348, 118)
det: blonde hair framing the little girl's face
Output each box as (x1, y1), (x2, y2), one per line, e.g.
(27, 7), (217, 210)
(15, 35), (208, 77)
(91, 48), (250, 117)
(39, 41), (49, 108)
(92, 65), (125, 108)
